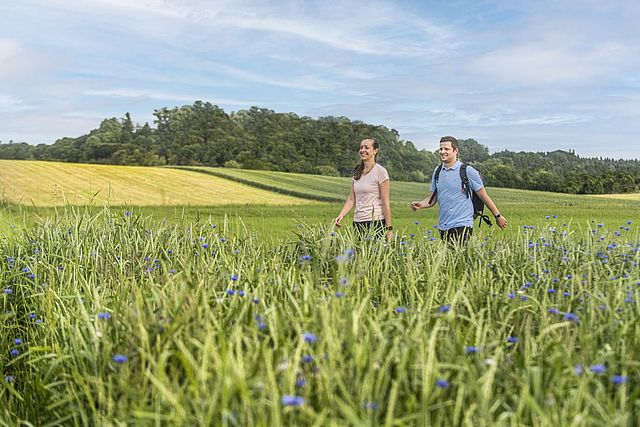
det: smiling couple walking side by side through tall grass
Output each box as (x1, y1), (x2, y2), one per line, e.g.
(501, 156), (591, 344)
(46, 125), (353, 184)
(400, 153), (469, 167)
(334, 136), (507, 243)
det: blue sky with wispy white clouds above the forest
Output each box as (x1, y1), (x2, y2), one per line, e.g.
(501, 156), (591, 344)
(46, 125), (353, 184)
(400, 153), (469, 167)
(0, 0), (640, 158)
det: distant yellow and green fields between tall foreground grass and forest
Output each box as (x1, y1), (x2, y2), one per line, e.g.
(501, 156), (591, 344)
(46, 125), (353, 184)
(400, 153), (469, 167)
(0, 161), (640, 237)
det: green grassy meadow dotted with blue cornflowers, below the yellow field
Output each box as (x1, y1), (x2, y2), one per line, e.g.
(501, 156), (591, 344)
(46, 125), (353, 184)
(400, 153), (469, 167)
(0, 162), (640, 426)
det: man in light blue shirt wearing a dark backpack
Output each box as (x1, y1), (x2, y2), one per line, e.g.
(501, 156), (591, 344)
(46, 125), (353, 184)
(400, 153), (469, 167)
(411, 136), (507, 243)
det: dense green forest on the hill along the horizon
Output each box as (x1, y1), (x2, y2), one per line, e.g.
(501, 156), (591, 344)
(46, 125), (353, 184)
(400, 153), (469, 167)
(0, 101), (640, 194)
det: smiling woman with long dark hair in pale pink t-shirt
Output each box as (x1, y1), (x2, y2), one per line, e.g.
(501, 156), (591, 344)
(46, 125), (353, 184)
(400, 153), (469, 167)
(335, 138), (393, 239)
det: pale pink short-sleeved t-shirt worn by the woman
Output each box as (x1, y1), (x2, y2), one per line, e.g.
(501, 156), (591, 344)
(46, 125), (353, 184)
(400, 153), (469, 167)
(353, 163), (389, 222)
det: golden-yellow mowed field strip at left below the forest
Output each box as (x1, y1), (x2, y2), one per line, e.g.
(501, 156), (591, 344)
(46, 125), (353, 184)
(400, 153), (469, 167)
(0, 160), (311, 206)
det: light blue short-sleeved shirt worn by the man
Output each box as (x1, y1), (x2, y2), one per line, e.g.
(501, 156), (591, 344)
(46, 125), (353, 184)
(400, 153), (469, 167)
(431, 160), (484, 230)
